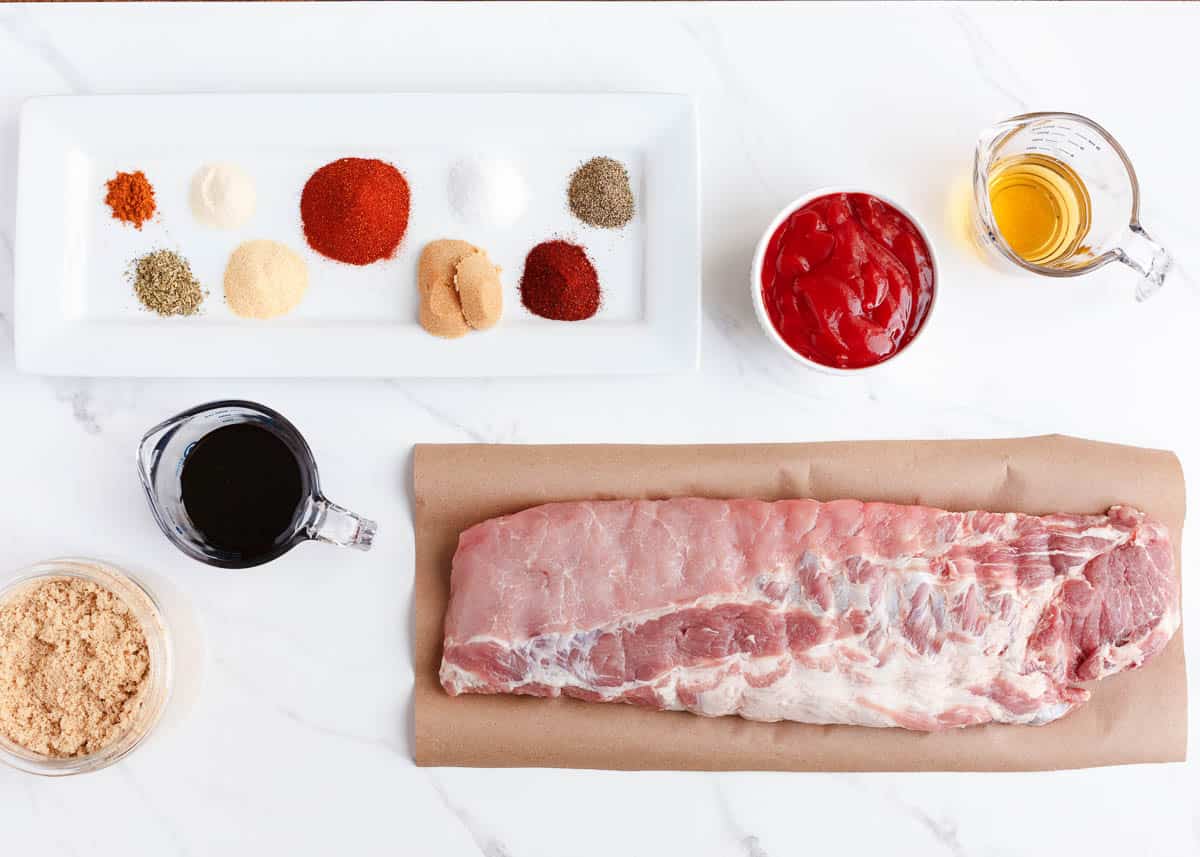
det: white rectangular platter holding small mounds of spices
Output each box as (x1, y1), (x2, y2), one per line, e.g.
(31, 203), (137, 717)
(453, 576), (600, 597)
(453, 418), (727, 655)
(16, 94), (700, 377)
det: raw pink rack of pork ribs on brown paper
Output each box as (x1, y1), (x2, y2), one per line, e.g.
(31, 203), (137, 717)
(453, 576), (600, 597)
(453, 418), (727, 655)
(440, 498), (1180, 730)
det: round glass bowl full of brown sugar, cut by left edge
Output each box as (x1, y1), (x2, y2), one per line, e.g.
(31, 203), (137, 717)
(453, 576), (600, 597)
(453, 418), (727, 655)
(0, 558), (174, 777)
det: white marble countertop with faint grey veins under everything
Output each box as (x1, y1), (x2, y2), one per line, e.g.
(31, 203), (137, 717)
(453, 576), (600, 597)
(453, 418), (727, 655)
(0, 4), (1200, 857)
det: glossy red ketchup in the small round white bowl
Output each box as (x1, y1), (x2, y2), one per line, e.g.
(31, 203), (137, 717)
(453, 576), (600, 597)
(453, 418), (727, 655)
(762, 193), (934, 368)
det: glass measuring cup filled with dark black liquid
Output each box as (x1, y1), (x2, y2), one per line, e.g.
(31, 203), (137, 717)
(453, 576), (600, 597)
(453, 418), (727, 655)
(138, 401), (376, 569)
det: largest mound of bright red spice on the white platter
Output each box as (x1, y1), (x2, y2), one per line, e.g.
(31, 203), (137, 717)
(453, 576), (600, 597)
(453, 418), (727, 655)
(300, 157), (409, 265)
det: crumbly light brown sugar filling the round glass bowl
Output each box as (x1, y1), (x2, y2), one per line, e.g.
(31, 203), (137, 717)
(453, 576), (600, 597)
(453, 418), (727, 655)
(0, 576), (150, 759)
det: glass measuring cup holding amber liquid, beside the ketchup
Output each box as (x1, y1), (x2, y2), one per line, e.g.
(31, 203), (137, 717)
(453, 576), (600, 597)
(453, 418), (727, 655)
(973, 113), (1171, 300)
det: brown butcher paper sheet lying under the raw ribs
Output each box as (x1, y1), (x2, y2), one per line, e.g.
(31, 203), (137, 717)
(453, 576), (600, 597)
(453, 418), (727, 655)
(413, 437), (1187, 771)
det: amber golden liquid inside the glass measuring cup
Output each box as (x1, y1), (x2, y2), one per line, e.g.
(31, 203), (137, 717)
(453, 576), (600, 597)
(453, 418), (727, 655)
(988, 152), (1092, 265)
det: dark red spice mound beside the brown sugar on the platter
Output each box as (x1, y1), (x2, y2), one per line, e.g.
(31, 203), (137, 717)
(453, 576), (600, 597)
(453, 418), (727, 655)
(521, 241), (600, 322)
